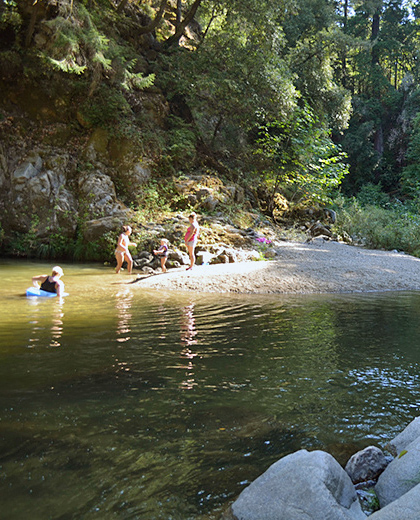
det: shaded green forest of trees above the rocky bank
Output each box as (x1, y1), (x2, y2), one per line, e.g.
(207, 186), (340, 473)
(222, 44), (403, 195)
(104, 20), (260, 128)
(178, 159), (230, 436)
(0, 0), (420, 254)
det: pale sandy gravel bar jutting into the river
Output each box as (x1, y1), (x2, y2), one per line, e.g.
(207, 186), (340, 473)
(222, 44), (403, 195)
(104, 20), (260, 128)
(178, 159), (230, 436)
(134, 239), (420, 294)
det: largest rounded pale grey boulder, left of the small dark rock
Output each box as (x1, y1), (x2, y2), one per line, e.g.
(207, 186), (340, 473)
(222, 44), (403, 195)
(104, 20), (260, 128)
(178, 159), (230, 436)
(225, 450), (366, 520)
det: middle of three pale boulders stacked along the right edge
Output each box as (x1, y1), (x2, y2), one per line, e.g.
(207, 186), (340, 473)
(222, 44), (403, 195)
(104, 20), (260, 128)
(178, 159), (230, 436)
(375, 437), (420, 507)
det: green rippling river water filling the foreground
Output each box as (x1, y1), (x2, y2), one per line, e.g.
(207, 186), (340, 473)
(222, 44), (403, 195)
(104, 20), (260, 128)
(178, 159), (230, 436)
(0, 260), (420, 520)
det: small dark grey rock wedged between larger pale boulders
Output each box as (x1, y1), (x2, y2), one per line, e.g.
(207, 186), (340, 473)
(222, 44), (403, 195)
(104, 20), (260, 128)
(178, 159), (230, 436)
(345, 446), (388, 484)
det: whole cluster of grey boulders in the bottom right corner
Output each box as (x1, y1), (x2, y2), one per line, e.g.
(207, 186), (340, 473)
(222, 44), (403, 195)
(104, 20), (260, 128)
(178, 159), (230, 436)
(222, 417), (420, 520)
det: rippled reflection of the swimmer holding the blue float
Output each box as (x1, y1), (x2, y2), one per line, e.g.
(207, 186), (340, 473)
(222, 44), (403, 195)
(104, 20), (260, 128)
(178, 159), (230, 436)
(28, 298), (64, 348)
